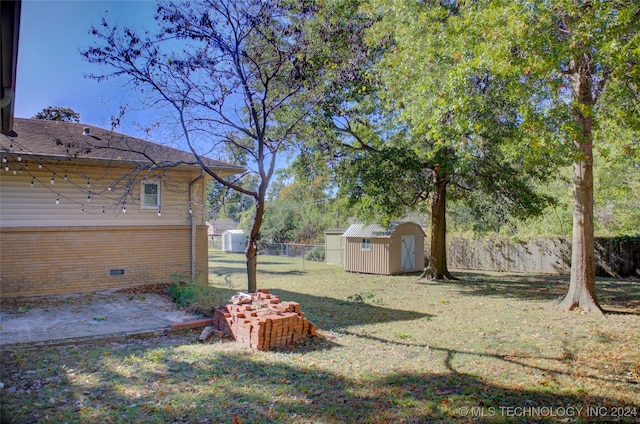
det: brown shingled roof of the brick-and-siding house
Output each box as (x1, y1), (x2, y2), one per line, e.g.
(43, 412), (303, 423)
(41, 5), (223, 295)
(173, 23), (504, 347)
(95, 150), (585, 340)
(0, 118), (244, 176)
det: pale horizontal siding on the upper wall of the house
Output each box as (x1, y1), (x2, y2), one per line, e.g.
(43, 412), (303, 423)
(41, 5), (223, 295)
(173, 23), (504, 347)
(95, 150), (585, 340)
(0, 163), (206, 227)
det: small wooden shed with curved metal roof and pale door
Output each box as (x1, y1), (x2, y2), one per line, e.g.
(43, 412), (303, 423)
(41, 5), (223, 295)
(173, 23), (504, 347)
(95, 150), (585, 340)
(342, 222), (425, 275)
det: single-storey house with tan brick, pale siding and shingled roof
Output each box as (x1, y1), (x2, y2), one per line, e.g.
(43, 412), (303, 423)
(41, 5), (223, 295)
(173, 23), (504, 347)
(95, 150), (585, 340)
(0, 118), (243, 297)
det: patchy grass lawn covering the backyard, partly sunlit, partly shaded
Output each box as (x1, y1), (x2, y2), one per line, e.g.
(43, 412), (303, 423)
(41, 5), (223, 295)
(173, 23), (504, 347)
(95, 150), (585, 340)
(0, 252), (640, 423)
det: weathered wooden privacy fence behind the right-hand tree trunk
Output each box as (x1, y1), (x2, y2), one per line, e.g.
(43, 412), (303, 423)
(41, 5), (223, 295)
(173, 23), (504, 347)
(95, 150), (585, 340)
(444, 236), (640, 278)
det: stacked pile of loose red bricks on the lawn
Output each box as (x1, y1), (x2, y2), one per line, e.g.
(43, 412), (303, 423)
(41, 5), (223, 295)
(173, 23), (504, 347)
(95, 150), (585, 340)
(213, 290), (316, 350)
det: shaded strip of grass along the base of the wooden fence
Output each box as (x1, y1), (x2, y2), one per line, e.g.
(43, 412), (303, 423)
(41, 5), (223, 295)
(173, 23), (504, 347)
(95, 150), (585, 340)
(420, 271), (640, 315)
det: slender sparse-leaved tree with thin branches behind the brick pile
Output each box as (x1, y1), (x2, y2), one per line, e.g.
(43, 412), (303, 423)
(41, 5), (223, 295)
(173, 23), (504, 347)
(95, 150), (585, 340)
(82, 0), (316, 292)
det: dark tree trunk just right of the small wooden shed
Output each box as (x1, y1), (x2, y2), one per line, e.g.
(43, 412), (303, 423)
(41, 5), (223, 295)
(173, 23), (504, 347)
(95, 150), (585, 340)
(420, 171), (456, 280)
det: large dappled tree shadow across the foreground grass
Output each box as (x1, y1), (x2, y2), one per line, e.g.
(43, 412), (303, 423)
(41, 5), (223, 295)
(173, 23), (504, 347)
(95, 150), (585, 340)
(2, 341), (636, 423)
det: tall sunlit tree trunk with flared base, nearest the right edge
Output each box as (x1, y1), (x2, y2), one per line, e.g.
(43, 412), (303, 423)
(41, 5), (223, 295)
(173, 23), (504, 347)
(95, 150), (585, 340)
(560, 59), (603, 313)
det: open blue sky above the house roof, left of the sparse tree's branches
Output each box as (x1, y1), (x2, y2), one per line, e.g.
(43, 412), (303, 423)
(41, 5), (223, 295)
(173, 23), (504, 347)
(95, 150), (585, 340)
(15, 0), (156, 136)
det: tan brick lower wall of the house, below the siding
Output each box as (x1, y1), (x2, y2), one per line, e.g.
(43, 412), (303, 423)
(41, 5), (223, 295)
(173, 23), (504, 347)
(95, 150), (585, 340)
(0, 225), (208, 297)
